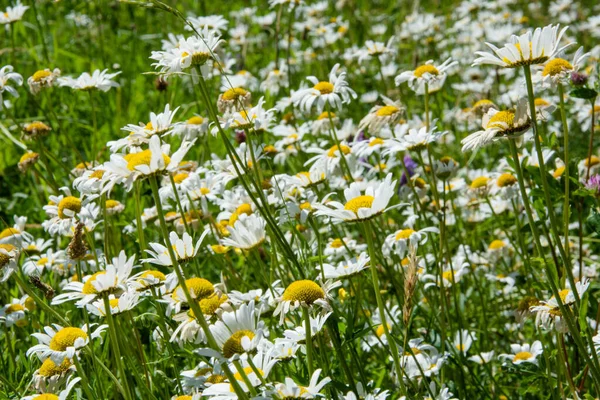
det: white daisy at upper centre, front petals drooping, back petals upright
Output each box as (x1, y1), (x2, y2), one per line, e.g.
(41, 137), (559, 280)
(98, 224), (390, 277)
(292, 64), (356, 113)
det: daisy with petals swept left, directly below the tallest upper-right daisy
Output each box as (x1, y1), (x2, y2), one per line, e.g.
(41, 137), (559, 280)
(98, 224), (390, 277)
(461, 98), (531, 152)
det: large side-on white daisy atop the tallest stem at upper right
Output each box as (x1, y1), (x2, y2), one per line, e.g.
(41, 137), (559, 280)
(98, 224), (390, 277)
(473, 25), (570, 68)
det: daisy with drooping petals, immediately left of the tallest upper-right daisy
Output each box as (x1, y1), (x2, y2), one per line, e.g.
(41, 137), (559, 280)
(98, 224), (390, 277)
(395, 58), (458, 94)
